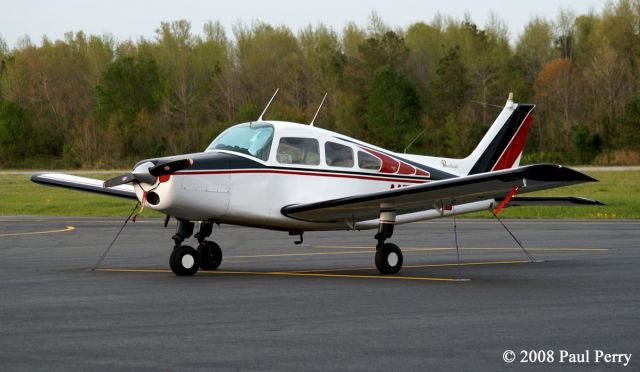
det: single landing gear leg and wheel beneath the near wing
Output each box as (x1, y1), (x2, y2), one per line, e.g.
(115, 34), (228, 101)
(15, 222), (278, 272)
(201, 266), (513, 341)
(375, 210), (402, 274)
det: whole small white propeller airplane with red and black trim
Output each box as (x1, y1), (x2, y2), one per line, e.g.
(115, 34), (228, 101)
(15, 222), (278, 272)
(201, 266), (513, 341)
(31, 90), (602, 276)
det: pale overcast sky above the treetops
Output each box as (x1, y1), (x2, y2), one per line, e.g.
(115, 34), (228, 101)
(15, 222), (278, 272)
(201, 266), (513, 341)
(0, 0), (607, 48)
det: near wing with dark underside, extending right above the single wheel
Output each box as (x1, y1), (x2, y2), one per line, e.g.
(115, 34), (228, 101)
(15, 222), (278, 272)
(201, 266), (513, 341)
(281, 164), (597, 222)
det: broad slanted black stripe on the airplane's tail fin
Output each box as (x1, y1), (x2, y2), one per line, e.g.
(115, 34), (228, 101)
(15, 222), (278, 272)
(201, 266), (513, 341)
(469, 104), (535, 174)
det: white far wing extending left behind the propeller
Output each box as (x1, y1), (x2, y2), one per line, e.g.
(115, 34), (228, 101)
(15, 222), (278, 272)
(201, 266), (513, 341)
(31, 173), (137, 199)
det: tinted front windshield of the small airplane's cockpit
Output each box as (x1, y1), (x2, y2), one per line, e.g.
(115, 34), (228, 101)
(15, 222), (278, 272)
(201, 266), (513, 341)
(207, 123), (273, 161)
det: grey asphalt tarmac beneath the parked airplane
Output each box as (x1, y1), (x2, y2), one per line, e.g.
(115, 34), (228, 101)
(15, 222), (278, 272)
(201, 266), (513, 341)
(0, 216), (640, 371)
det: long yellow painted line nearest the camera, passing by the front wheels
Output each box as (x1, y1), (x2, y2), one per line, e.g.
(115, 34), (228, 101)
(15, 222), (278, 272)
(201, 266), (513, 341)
(96, 269), (471, 282)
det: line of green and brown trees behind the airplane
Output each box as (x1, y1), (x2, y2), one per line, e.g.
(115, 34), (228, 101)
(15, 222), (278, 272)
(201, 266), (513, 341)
(0, 0), (640, 168)
